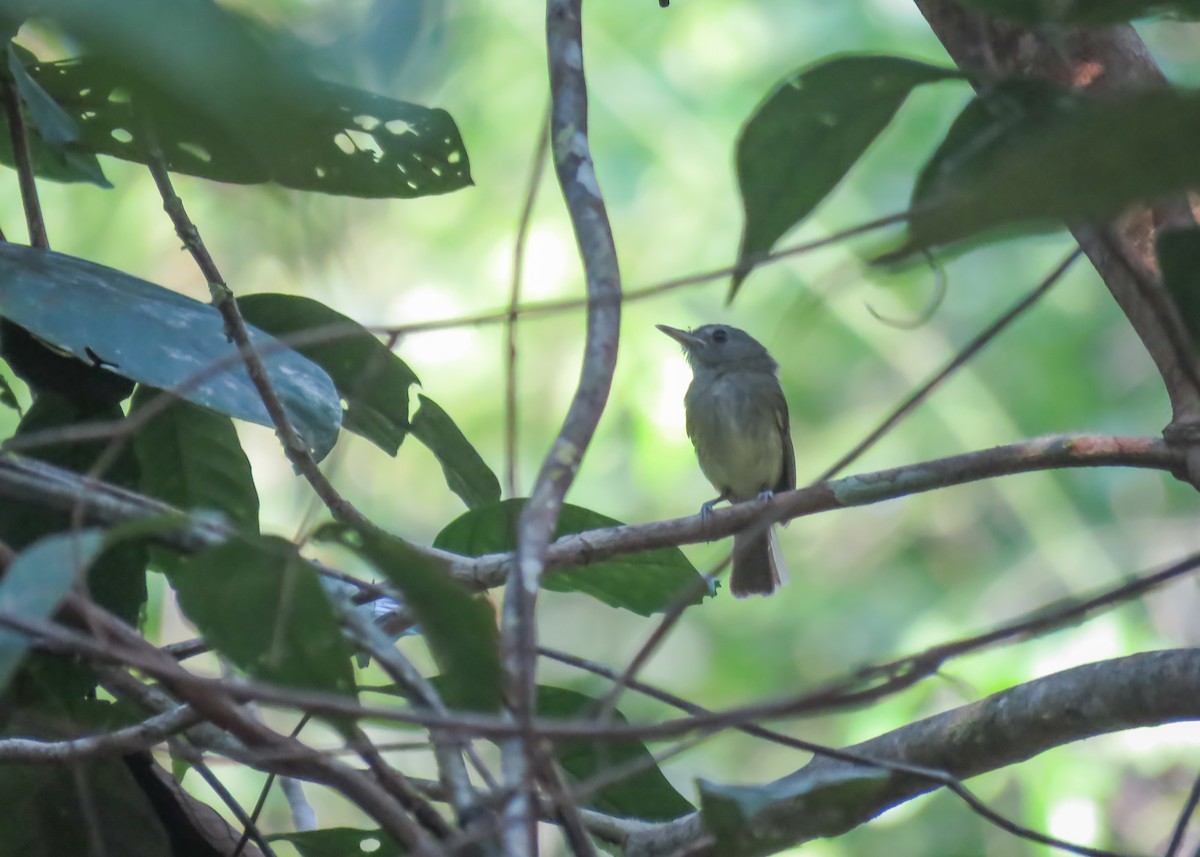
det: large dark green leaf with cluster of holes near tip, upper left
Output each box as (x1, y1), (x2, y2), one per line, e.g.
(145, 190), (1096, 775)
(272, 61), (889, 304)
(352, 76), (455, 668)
(22, 0), (470, 197)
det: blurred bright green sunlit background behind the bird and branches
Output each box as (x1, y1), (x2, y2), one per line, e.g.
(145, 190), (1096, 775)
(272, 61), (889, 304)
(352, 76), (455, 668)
(7, 0), (1200, 857)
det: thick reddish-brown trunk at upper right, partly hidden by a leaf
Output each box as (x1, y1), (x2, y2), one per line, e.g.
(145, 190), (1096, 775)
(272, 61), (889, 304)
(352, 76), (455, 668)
(914, 0), (1200, 436)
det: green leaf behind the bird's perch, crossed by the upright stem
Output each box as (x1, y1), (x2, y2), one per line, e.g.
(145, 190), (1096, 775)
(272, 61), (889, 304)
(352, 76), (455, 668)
(433, 498), (709, 616)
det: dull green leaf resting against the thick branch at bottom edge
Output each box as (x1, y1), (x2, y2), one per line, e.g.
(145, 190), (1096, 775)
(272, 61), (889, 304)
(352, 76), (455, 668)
(698, 767), (892, 857)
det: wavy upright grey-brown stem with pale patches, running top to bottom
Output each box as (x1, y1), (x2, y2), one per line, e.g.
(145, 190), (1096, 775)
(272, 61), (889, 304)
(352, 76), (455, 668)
(500, 0), (620, 857)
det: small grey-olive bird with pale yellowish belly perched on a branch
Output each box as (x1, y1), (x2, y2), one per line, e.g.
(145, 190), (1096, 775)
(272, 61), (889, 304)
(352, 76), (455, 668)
(656, 324), (796, 598)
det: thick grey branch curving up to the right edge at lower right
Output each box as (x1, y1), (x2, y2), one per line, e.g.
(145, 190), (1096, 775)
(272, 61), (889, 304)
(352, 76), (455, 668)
(625, 649), (1200, 857)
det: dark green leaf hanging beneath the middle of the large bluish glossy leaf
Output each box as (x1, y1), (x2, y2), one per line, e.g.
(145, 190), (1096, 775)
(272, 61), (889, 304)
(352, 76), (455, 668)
(130, 386), (258, 534)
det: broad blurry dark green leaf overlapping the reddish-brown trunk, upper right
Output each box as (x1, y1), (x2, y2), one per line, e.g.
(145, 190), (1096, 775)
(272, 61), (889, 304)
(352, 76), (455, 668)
(897, 80), (1200, 262)
